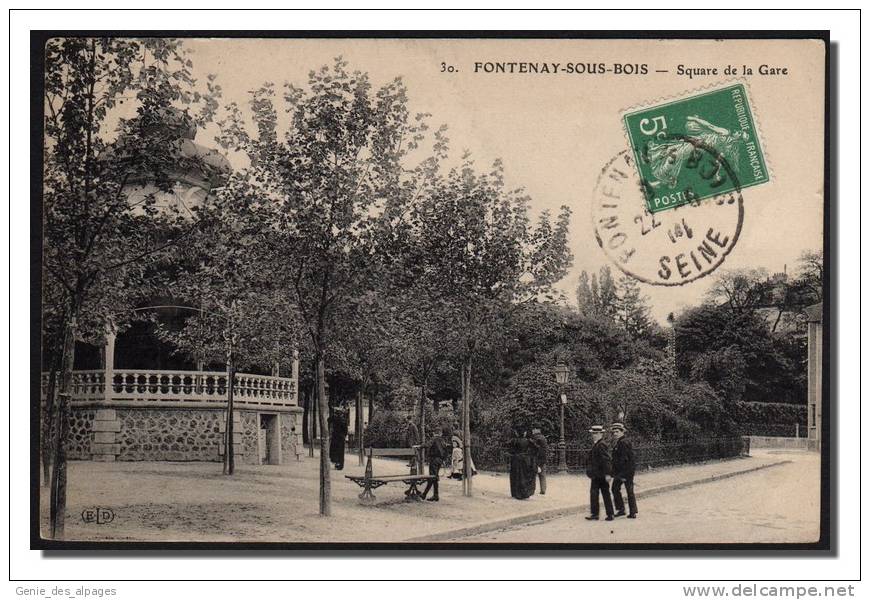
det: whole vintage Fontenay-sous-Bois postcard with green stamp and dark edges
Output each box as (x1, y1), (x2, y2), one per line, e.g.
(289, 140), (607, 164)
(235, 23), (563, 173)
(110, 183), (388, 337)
(31, 31), (833, 550)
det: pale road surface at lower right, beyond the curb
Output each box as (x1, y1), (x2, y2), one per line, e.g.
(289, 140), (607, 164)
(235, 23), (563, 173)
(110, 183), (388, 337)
(457, 452), (820, 543)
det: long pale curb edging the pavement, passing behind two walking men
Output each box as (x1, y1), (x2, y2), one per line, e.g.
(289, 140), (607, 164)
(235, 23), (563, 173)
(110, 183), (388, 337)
(404, 460), (792, 543)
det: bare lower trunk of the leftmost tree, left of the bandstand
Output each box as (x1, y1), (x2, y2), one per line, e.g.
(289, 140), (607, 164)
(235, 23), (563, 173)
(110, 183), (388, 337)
(49, 317), (76, 540)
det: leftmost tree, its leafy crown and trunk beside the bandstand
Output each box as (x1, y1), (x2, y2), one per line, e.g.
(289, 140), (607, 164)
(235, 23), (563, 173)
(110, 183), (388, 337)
(42, 37), (219, 538)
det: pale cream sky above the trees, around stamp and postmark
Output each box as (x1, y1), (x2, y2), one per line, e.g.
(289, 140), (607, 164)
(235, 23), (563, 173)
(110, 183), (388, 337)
(185, 39), (824, 322)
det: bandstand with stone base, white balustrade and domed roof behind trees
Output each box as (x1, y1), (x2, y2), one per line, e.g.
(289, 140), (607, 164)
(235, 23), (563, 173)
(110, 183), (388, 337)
(42, 111), (302, 464)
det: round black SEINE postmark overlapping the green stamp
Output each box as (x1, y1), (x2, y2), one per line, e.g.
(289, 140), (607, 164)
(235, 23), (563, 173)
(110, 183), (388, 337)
(592, 134), (743, 286)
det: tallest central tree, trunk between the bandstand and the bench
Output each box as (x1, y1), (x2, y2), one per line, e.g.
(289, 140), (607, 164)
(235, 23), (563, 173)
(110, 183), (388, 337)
(220, 58), (436, 516)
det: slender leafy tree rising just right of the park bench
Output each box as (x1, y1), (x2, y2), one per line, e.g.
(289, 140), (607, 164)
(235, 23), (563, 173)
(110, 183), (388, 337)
(412, 156), (572, 495)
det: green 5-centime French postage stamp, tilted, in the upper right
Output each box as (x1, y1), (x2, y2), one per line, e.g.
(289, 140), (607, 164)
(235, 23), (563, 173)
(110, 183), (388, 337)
(623, 83), (770, 213)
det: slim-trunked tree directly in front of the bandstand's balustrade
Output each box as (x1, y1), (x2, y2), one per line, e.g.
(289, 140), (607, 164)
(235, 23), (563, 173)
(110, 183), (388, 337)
(158, 178), (299, 475)
